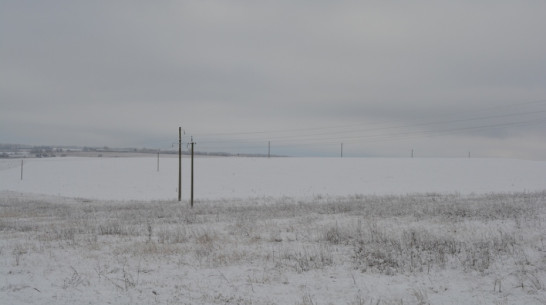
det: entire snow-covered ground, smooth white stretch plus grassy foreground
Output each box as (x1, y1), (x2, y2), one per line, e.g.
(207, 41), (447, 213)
(0, 158), (546, 304)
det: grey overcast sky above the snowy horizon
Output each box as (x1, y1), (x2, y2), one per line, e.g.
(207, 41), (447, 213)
(0, 0), (546, 160)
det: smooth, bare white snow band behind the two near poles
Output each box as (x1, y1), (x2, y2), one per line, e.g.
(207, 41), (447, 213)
(0, 157), (546, 200)
